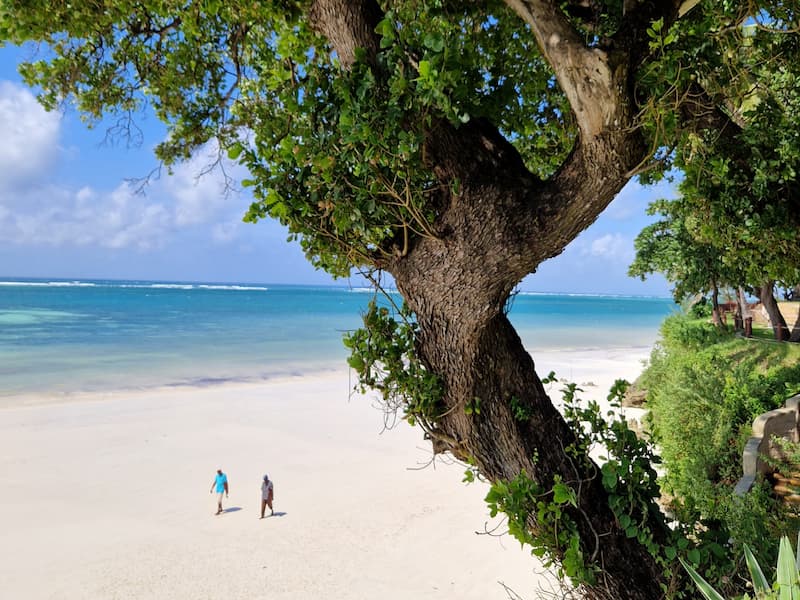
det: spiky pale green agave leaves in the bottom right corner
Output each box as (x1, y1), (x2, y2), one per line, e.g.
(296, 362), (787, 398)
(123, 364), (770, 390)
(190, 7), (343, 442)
(680, 535), (800, 600)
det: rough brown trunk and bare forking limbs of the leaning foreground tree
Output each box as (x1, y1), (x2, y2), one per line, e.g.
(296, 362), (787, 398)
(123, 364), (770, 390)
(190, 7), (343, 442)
(310, 0), (680, 600)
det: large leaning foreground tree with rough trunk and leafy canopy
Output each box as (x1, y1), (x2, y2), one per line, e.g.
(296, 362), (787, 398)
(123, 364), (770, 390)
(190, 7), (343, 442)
(0, 0), (796, 600)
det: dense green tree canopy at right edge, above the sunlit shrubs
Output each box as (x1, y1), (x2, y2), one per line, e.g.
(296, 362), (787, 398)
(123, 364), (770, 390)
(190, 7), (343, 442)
(629, 22), (800, 339)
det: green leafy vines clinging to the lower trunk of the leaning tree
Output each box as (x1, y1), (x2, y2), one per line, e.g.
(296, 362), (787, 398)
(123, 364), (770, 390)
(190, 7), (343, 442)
(345, 304), (700, 592)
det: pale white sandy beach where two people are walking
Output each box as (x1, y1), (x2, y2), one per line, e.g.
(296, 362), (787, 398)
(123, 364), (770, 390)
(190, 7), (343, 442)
(0, 349), (647, 600)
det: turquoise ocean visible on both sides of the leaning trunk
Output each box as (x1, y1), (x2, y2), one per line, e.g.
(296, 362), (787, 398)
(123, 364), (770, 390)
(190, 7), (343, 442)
(0, 278), (675, 397)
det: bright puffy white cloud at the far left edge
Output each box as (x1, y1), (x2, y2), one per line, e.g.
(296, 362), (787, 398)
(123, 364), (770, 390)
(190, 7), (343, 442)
(0, 81), (61, 189)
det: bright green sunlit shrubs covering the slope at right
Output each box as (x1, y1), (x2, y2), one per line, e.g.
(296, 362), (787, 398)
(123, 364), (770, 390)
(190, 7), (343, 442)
(641, 315), (800, 591)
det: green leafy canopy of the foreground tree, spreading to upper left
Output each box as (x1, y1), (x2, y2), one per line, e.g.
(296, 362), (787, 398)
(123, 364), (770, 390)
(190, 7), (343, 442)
(0, 0), (575, 276)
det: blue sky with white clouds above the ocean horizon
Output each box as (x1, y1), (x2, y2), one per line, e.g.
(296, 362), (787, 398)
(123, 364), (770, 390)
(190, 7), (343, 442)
(0, 48), (674, 295)
